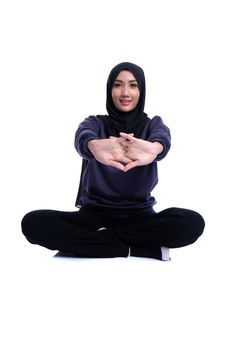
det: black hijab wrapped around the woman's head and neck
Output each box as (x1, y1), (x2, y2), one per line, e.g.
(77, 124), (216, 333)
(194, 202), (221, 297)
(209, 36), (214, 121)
(106, 62), (148, 137)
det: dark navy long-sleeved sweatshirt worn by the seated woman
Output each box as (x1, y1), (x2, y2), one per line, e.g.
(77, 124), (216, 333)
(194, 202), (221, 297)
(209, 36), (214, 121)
(75, 116), (171, 210)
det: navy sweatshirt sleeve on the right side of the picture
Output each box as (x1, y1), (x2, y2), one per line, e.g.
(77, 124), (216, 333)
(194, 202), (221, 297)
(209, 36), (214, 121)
(147, 116), (171, 161)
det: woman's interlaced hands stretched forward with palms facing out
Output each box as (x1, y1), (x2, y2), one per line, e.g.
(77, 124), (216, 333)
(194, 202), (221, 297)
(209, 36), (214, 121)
(88, 132), (163, 172)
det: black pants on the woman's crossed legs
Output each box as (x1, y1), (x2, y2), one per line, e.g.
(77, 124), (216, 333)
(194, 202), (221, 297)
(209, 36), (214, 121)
(22, 206), (205, 259)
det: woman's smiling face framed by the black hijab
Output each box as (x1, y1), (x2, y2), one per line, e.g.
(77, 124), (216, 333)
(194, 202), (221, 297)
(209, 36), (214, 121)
(111, 70), (140, 112)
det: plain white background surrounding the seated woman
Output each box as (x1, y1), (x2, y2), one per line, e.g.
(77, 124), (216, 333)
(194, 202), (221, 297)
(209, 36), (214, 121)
(0, 0), (234, 350)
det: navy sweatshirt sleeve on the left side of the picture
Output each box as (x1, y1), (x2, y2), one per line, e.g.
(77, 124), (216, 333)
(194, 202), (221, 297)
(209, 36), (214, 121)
(75, 116), (100, 160)
